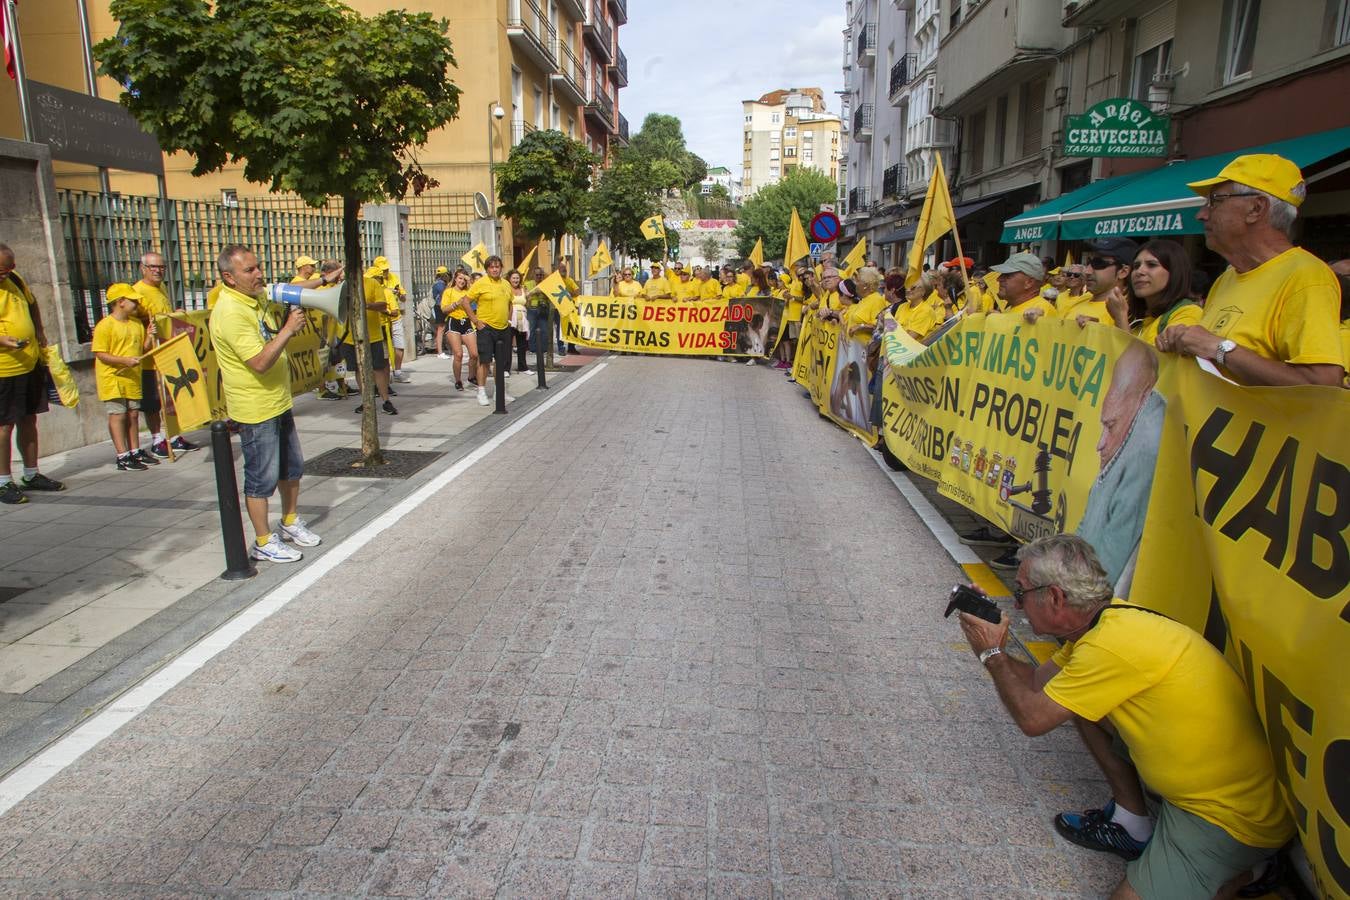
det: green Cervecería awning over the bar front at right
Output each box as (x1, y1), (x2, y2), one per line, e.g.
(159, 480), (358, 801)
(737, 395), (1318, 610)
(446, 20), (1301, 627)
(1003, 127), (1350, 243)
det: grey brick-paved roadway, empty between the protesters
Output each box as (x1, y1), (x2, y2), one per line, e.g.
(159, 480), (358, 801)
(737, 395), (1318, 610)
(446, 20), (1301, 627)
(0, 358), (1121, 897)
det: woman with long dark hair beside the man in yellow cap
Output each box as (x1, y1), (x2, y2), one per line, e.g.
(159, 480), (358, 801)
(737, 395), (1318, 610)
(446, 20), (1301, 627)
(1107, 239), (1204, 344)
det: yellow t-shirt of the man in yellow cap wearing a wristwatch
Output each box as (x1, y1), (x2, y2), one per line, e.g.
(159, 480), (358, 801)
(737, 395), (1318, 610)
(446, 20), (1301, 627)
(1200, 247), (1345, 381)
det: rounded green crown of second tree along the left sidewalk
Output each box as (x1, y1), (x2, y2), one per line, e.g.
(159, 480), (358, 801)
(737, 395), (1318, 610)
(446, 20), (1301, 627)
(497, 130), (599, 240)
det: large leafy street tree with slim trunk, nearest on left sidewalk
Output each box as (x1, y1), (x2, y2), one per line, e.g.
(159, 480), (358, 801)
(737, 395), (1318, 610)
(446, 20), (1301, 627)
(95, 0), (460, 466)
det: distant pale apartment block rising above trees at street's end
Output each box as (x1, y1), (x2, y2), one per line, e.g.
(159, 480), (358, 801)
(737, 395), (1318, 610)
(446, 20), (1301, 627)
(741, 88), (840, 196)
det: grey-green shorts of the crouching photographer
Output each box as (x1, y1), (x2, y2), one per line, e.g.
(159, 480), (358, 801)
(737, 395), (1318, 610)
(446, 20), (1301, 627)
(1125, 800), (1276, 900)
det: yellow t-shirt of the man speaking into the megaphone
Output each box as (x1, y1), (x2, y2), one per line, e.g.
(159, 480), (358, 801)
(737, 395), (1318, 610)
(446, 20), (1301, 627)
(209, 287), (292, 425)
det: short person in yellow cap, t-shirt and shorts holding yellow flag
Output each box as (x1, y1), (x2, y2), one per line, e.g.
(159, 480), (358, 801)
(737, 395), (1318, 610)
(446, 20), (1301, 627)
(89, 283), (159, 472)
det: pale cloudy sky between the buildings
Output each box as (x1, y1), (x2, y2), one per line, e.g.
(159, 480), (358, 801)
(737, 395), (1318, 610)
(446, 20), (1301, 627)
(618, 0), (844, 178)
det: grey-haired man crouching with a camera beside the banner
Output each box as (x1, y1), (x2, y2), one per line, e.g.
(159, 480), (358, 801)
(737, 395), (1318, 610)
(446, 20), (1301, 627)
(953, 534), (1293, 900)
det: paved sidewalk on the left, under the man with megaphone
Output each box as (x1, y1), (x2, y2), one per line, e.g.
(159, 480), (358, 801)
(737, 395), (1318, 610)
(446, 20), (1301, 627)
(0, 355), (597, 772)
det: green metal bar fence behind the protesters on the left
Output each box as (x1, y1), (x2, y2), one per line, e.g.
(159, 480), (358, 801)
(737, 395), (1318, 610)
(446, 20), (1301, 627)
(58, 190), (385, 343)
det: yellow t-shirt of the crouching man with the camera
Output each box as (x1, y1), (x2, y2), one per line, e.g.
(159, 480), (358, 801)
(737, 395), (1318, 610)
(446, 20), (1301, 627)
(1045, 609), (1293, 847)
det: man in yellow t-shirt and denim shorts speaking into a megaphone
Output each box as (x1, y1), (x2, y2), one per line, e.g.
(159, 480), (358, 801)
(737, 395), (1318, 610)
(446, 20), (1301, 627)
(211, 244), (320, 563)
